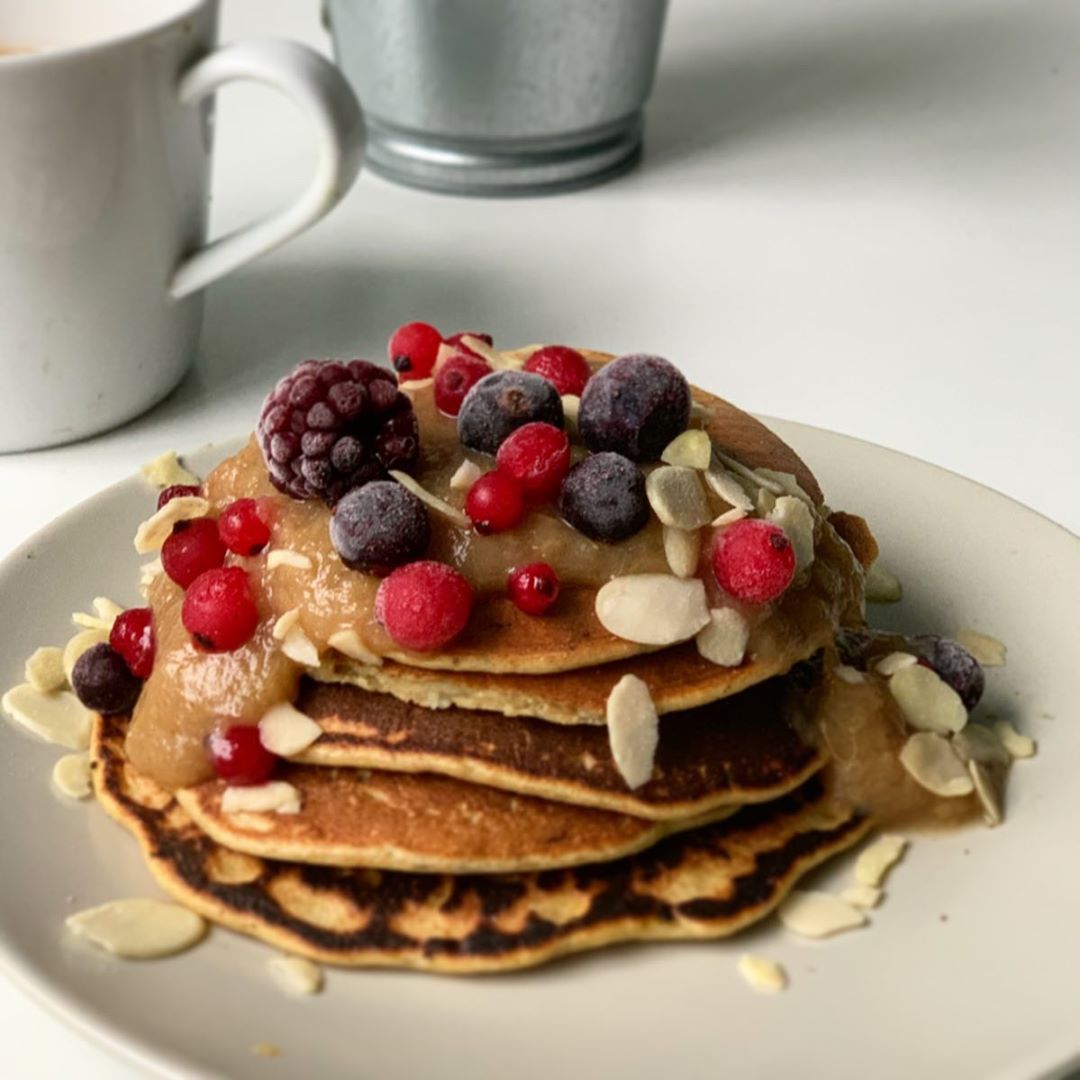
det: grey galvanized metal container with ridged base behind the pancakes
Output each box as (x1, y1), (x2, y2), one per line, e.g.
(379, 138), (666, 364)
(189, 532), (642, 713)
(326, 0), (667, 195)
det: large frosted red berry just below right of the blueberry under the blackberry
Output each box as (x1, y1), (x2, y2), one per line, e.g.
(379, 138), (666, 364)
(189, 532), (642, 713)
(375, 562), (473, 652)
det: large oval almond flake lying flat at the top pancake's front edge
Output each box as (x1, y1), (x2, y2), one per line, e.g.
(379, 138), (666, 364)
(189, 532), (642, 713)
(596, 573), (710, 645)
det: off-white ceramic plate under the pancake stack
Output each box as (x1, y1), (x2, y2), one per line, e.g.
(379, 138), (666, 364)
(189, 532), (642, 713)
(0, 422), (1080, 1080)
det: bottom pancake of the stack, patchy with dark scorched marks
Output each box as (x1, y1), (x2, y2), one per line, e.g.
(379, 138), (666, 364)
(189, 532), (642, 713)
(92, 719), (869, 974)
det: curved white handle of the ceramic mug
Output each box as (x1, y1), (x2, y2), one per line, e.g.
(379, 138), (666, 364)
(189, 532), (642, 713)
(168, 40), (364, 300)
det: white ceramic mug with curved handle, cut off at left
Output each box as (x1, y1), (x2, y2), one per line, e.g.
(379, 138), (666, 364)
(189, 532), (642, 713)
(0, 0), (364, 451)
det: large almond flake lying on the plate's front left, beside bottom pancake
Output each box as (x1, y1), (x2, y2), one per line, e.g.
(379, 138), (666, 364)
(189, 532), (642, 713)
(65, 897), (206, 960)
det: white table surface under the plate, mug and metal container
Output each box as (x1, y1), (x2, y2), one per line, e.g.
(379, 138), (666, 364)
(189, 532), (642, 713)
(0, 0), (1080, 1080)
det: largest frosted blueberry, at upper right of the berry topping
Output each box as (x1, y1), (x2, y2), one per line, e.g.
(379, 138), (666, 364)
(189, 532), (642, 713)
(578, 354), (690, 461)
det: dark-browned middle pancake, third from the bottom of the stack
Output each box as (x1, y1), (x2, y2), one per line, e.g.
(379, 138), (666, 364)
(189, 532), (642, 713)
(291, 665), (826, 816)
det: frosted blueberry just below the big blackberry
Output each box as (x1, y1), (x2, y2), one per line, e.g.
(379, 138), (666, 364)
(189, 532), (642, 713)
(330, 480), (431, 573)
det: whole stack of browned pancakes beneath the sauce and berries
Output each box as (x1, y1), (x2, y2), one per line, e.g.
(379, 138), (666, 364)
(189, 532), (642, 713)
(93, 378), (873, 972)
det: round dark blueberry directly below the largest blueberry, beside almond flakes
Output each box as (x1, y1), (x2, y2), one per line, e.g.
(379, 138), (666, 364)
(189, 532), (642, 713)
(558, 453), (649, 543)
